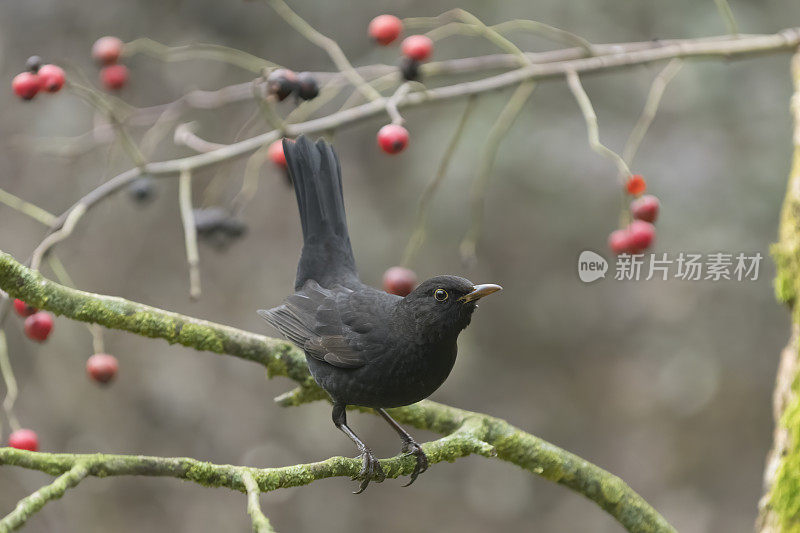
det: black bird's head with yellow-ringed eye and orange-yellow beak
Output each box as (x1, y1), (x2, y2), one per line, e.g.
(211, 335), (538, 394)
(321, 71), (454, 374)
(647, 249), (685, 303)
(402, 276), (502, 336)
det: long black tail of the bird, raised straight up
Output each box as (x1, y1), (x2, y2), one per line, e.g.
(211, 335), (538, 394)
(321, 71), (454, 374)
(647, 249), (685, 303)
(283, 135), (358, 289)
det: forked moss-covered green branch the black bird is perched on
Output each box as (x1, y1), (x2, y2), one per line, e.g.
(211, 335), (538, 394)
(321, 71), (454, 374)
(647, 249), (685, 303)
(0, 252), (674, 532)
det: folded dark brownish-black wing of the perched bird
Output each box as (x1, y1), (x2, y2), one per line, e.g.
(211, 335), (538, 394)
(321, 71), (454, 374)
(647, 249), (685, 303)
(259, 280), (397, 368)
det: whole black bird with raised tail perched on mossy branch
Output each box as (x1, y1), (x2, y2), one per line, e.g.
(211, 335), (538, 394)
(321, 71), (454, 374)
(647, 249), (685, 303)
(259, 136), (501, 494)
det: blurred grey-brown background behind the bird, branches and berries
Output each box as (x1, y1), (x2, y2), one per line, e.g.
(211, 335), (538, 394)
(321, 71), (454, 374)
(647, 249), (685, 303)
(0, 0), (800, 533)
